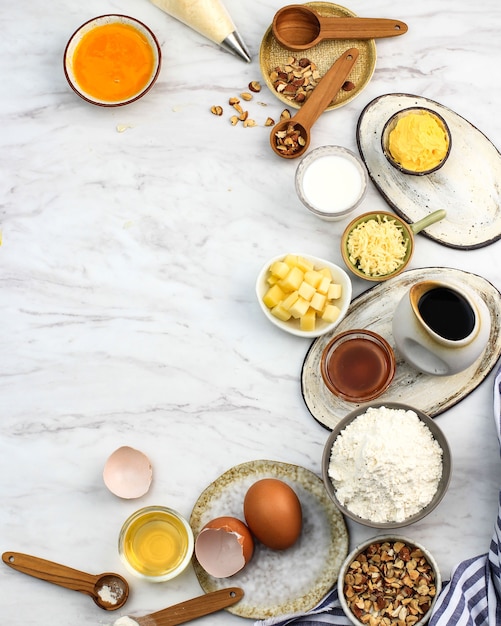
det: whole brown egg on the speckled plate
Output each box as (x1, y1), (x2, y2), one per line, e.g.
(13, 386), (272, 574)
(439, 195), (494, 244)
(244, 478), (303, 550)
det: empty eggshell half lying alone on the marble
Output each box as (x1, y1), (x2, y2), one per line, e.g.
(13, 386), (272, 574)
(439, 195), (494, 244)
(103, 446), (153, 499)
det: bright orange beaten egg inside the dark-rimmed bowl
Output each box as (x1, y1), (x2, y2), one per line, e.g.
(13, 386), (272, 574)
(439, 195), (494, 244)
(73, 23), (155, 102)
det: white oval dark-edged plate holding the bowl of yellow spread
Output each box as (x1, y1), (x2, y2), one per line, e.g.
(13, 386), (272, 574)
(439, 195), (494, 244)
(357, 93), (501, 250)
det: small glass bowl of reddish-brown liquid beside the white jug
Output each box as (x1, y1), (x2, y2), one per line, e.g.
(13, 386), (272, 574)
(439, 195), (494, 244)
(320, 329), (396, 402)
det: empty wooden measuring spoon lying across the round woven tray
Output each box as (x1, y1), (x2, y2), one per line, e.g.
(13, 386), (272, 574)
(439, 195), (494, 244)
(272, 4), (408, 50)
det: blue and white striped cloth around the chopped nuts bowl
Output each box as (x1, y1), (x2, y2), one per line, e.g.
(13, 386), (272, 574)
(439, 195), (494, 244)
(255, 367), (501, 626)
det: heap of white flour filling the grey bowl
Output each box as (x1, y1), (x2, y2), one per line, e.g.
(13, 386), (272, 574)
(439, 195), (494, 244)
(329, 407), (442, 522)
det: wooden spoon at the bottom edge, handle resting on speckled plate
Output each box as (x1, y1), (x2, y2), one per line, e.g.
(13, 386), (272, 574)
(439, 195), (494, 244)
(124, 587), (244, 626)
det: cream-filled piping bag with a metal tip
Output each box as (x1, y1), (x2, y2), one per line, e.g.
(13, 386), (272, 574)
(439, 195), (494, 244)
(147, 0), (251, 63)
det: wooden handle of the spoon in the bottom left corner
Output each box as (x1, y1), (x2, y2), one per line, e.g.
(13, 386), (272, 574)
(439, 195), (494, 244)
(2, 552), (99, 596)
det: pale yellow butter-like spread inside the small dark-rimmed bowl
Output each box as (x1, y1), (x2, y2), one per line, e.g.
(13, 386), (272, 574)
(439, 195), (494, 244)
(388, 112), (449, 172)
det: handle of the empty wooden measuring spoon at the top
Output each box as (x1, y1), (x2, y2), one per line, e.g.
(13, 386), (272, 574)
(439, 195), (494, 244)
(319, 17), (408, 39)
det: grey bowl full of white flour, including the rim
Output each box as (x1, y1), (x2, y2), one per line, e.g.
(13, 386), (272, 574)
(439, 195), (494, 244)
(322, 402), (452, 529)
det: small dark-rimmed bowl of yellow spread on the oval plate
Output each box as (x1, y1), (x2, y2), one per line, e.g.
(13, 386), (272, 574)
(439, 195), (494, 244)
(381, 107), (452, 176)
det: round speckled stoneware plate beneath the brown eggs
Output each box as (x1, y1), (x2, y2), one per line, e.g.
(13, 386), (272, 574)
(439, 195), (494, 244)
(190, 460), (348, 619)
